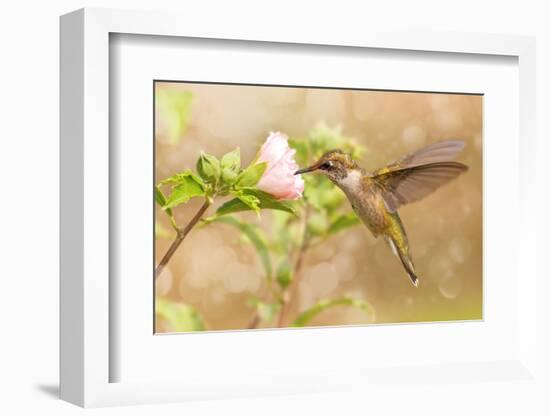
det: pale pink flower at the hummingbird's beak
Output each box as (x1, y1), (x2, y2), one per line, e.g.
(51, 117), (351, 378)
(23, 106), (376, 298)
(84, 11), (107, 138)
(256, 132), (304, 199)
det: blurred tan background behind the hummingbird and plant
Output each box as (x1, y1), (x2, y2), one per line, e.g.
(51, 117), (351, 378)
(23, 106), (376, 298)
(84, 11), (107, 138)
(155, 82), (483, 332)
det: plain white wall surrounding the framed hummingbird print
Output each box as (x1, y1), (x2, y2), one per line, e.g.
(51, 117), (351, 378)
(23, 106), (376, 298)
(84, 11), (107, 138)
(0, 0), (550, 415)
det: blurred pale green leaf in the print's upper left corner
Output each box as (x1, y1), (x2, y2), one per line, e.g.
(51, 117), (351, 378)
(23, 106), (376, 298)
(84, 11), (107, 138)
(155, 88), (193, 144)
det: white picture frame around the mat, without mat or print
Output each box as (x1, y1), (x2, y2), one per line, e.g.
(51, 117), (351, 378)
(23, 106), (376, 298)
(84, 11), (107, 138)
(60, 9), (539, 407)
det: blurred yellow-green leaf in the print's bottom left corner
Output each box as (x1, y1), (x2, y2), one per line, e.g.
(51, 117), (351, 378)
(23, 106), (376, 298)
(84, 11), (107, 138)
(155, 298), (206, 332)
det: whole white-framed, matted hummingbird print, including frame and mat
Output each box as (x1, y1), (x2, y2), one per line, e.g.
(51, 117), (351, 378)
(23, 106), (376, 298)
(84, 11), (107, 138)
(61, 9), (539, 406)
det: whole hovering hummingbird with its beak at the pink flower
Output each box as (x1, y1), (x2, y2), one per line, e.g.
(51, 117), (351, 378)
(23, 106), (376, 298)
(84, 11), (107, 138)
(294, 140), (468, 287)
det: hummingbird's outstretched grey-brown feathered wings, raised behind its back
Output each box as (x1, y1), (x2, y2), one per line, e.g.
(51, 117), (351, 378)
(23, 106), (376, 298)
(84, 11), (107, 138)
(371, 140), (468, 212)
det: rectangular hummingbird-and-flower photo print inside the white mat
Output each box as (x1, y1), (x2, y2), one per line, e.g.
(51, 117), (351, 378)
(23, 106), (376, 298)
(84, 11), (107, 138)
(154, 81), (483, 333)
